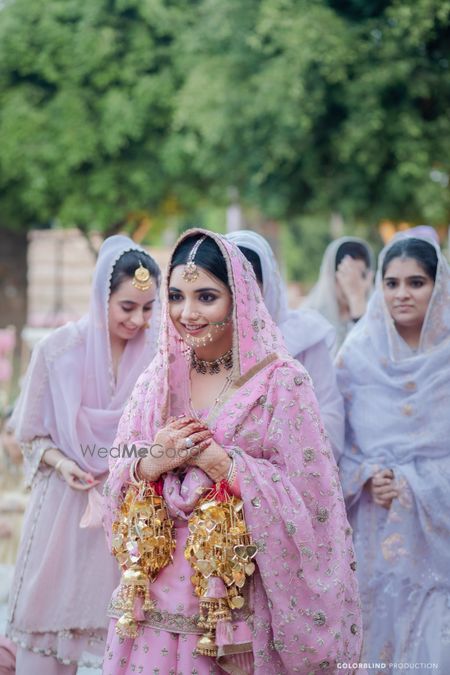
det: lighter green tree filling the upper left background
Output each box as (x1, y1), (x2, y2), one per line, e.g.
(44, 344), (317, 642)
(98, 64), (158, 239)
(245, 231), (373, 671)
(0, 0), (188, 231)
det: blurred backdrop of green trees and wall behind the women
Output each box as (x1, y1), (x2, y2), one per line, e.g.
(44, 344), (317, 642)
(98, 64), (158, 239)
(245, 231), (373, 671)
(0, 0), (450, 408)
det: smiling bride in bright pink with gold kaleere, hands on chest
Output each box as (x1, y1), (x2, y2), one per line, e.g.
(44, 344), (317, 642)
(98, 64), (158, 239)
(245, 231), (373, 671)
(104, 230), (361, 675)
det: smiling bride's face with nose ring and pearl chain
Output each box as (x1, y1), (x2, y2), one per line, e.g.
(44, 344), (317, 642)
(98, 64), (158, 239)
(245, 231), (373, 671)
(169, 265), (233, 351)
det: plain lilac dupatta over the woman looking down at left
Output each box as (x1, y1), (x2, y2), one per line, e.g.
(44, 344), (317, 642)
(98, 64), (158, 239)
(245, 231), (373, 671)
(10, 235), (160, 482)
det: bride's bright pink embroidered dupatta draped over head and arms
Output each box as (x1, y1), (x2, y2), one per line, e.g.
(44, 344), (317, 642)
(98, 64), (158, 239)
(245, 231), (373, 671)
(106, 230), (361, 675)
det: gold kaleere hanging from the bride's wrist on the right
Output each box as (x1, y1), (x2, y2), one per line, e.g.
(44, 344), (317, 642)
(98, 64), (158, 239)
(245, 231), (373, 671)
(184, 481), (257, 657)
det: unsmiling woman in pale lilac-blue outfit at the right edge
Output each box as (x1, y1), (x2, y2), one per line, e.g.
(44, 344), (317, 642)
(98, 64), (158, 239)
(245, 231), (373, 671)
(337, 235), (450, 673)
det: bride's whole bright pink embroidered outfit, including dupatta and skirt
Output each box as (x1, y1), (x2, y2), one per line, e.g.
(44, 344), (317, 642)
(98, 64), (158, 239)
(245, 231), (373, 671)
(103, 230), (361, 675)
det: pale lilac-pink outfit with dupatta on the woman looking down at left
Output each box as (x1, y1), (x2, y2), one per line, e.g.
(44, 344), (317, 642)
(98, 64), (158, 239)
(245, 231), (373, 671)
(7, 236), (158, 675)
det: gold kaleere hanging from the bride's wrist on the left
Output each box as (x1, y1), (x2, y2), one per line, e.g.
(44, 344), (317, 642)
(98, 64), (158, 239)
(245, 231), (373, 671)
(112, 481), (176, 638)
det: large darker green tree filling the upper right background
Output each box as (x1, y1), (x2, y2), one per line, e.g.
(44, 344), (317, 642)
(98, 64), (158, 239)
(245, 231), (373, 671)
(169, 0), (450, 224)
